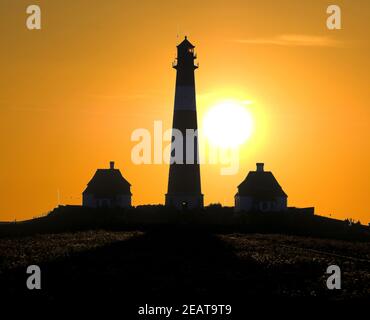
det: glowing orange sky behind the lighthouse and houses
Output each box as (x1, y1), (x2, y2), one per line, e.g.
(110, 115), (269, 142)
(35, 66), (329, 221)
(0, 0), (370, 223)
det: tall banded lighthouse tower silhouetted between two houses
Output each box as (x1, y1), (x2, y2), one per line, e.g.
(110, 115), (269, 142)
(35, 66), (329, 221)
(166, 37), (203, 209)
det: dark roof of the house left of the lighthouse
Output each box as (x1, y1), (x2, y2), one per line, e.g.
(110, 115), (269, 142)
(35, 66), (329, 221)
(84, 168), (131, 198)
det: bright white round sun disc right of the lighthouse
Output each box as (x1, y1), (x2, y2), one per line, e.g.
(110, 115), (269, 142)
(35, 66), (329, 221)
(203, 100), (253, 148)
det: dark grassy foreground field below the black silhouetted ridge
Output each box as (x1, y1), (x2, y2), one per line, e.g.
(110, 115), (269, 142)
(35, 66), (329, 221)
(0, 229), (370, 313)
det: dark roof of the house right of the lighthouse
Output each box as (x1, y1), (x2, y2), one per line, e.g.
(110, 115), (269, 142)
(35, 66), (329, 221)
(238, 169), (287, 199)
